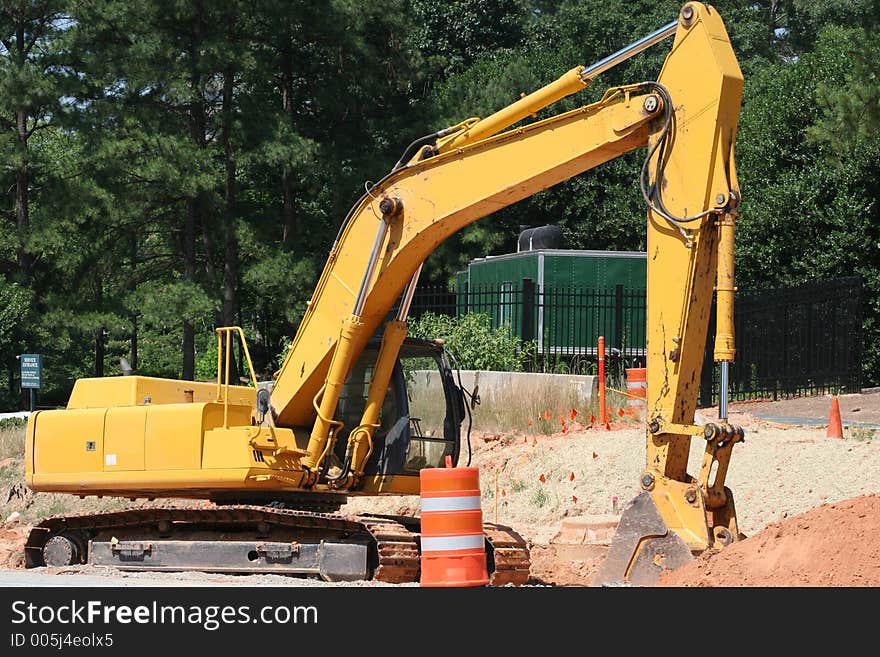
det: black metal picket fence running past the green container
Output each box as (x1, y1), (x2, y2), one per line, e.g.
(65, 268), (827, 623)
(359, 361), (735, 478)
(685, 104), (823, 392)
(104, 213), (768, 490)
(410, 277), (863, 406)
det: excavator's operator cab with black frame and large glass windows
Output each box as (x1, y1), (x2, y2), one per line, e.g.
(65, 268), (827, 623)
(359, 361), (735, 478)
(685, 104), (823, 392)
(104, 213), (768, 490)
(334, 338), (466, 476)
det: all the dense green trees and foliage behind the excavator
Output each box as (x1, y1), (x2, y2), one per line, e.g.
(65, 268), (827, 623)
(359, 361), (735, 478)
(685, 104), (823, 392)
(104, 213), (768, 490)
(0, 0), (880, 408)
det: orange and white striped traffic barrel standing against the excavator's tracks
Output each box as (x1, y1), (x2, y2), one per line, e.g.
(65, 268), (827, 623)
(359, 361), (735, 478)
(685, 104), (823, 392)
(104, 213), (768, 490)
(419, 468), (489, 587)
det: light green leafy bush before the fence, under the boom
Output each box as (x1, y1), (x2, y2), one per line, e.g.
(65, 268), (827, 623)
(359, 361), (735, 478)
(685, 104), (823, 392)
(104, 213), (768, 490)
(409, 312), (524, 372)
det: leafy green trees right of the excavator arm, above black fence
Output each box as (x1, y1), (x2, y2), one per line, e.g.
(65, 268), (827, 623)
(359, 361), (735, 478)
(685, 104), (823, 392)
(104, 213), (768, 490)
(737, 26), (880, 385)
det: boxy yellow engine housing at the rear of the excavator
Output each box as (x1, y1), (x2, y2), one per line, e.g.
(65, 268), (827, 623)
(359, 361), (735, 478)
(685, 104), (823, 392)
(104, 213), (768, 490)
(26, 376), (314, 497)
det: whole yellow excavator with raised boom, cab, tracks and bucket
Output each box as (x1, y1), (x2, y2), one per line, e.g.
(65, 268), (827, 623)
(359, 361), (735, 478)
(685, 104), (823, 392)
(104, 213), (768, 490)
(25, 2), (743, 585)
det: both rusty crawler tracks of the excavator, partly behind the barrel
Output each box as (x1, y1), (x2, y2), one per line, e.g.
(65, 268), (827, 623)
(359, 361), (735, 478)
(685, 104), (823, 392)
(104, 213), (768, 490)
(25, 505), (529, 586)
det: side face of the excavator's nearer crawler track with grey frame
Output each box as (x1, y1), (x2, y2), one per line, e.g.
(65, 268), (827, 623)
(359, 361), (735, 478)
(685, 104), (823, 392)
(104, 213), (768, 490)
(25, 505), (382, 581)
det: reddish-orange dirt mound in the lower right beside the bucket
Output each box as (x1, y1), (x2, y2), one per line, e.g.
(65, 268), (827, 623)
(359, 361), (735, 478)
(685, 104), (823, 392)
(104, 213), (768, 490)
(659, 495), (880, 587)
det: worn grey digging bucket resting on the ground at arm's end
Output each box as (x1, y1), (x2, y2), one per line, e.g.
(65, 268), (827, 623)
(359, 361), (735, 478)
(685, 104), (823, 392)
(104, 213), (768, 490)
(592, 492), (693, 586)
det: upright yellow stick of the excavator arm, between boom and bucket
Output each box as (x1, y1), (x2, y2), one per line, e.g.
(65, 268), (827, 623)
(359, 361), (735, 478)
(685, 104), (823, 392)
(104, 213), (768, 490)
(647, 2), (743, 481)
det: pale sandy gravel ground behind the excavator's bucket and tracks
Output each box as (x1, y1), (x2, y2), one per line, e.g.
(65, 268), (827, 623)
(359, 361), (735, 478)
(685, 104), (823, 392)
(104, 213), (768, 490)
(345, 416), (880, 544)
